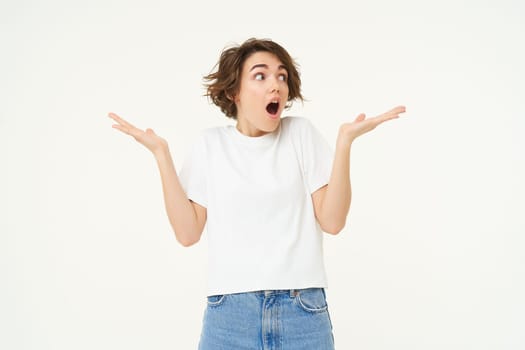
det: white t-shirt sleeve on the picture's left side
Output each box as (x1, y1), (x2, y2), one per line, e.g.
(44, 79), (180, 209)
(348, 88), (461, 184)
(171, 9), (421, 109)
(178, 133), (208, 207)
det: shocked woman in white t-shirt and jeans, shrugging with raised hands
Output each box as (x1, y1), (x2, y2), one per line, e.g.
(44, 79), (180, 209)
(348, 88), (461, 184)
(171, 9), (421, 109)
(109, 39), (405, 350)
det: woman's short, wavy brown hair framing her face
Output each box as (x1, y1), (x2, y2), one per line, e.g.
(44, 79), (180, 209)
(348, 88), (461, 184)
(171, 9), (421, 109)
(204, 38), (303, 119)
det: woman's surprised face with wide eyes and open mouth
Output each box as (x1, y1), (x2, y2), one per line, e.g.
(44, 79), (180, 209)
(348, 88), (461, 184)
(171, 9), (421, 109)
(235, 51), (288, 137)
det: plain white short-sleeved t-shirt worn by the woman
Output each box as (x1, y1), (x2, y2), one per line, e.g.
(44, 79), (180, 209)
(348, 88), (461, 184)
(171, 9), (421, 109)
(179, 117), (333, 295)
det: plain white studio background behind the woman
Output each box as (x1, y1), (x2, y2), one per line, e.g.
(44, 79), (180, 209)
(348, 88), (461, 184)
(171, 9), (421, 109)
(0, 0), (525, 350)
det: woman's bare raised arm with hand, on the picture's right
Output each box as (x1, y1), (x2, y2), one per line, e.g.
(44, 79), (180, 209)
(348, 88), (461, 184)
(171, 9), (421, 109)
(312, 106), (405, 234)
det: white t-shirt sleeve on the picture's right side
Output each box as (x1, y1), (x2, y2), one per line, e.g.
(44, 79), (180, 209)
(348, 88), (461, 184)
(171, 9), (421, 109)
(301, 118), (334, 193)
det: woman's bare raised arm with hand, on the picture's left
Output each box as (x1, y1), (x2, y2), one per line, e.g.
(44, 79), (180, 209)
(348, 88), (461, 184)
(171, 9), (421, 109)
(109, 113), (206, 247)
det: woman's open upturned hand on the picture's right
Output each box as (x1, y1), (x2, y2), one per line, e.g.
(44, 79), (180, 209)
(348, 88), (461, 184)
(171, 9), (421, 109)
(337, 106), (405, 147)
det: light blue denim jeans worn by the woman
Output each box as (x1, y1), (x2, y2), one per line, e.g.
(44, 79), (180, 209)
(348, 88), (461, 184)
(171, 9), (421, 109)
(199, 288), (334, 350)
